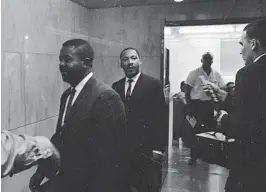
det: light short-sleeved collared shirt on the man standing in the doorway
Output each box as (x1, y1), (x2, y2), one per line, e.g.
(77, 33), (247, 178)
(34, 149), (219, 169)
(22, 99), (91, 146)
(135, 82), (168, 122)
(186, 67), (225, 101)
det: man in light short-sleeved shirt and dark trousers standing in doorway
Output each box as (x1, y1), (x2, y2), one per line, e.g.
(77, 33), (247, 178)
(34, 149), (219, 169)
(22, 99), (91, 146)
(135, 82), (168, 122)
(185, 52), (225, 165)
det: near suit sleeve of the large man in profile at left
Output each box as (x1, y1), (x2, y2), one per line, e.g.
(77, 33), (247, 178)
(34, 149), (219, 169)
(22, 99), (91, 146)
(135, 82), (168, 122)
(93, 90), (126, 191)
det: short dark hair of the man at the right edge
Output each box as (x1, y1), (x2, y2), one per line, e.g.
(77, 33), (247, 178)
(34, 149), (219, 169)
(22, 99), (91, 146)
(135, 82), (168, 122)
(243, 19), (266, 48)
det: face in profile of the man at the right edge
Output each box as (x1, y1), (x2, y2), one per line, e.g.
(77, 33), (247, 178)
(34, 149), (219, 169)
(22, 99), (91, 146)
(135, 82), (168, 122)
(239, 31), (255, 65)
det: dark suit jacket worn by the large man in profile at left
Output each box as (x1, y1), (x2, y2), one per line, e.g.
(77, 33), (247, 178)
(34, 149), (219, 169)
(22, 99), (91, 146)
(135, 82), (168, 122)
(52, 77), (126, 192)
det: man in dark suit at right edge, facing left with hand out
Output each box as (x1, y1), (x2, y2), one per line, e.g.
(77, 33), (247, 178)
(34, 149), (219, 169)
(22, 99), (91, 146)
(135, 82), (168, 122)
(207, 20), (266, 192)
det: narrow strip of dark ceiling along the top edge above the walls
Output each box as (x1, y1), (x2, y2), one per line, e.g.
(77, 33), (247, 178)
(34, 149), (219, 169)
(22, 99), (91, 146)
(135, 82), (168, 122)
(71, 0), (222, 9)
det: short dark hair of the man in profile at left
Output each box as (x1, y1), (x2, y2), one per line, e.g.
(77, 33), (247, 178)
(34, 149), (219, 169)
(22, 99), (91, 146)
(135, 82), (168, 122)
(62, 39), (94, 61)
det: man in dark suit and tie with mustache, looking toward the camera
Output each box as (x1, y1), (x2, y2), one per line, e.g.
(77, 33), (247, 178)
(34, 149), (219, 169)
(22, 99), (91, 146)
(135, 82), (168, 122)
(112, 48), (167, 192)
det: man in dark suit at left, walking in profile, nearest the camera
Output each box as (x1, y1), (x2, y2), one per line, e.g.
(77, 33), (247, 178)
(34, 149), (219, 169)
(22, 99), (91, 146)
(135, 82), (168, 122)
(30, 39), (126, 192)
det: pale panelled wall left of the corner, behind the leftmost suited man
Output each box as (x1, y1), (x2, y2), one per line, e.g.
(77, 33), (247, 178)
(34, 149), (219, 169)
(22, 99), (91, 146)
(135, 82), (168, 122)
(1, 0), (89, 192)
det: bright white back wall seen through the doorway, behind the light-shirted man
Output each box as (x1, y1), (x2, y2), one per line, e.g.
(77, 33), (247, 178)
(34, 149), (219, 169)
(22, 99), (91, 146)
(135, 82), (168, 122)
(165, 24), (246, 94)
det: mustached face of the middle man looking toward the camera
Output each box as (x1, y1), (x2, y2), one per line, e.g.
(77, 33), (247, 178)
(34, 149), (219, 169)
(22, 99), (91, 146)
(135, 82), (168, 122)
(121, 49), (141, 78)
